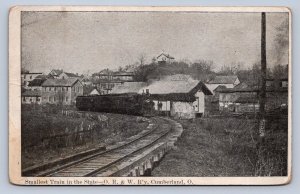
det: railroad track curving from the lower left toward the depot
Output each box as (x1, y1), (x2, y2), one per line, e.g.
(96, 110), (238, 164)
(27, 118), (172, 177)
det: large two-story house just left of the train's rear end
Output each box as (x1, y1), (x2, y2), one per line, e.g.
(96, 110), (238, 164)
(42, 78), (83, 105)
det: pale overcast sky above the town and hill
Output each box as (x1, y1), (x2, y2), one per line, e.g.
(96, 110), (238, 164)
(22, 12), (288, 73)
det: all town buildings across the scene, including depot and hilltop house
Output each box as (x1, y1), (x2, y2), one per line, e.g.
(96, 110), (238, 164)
(21, 54), (288, 119)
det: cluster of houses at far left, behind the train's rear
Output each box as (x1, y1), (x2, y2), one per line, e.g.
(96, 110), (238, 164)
(21, 69), (137, 105)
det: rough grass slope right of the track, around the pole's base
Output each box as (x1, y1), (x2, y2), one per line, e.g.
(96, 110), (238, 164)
(152, 118), (287, 177)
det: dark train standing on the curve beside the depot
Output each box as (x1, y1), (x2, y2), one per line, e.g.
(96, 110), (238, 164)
(76, 93), (154, 116)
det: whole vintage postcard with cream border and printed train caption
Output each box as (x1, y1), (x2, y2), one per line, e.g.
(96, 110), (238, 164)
(9, 6), (292, 185)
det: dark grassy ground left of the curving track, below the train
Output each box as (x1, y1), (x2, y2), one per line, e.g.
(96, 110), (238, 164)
(21, 105), (148, 168)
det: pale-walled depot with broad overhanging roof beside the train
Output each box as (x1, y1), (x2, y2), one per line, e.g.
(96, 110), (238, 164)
(139, 74), (212, 119)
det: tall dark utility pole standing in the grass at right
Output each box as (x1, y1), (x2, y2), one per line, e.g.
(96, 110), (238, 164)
(259, 12), (267, 142)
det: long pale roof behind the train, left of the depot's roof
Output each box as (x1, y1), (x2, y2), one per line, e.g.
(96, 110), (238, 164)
(111, 82), (146, 94)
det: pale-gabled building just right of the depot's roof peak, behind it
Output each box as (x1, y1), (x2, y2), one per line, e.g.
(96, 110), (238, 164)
(206, 75), (240, 93)
